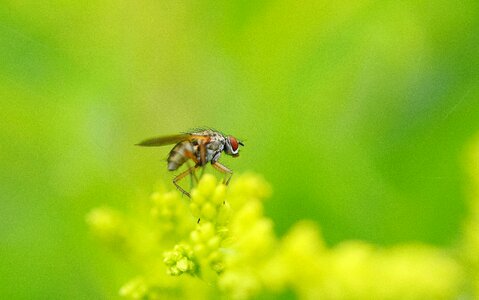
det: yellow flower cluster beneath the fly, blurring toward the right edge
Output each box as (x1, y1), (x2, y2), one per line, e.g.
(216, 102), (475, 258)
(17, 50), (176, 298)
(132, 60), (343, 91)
(87, 143), (479, 299)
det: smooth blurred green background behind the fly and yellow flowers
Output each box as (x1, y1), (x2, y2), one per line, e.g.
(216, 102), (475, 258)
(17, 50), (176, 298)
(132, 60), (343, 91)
(0, 0), (479, 299)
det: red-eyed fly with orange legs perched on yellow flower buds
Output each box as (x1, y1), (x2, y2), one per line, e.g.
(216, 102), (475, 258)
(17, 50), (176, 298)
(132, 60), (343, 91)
(137, 129), (244, 197)
